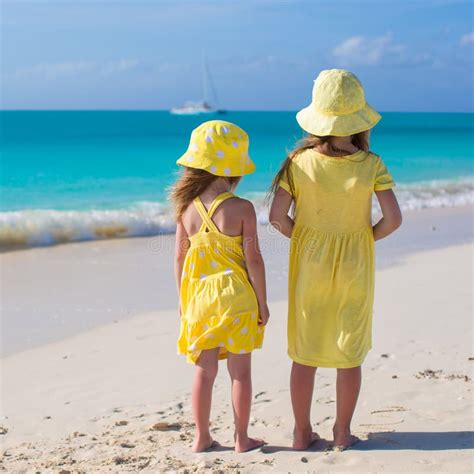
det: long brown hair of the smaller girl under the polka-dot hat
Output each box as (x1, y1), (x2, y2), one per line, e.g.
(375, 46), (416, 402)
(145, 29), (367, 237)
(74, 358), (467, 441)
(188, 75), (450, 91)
(169, 167), (240, 221)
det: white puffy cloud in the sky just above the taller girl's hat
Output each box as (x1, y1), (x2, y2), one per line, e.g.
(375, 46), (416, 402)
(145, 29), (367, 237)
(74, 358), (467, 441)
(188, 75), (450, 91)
(332, 32), (436, 66)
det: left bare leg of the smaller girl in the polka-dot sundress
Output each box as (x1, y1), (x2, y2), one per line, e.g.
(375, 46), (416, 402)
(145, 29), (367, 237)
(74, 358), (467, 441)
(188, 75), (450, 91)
(192, 348), (219, 453)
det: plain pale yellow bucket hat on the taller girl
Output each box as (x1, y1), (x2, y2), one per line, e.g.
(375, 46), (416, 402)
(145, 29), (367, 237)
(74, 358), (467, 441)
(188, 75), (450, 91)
(296, 69), (382, 137)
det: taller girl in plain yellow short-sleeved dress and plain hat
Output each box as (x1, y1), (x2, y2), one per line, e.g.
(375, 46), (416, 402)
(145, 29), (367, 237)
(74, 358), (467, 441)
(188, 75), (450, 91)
(270, 69), (401, 449)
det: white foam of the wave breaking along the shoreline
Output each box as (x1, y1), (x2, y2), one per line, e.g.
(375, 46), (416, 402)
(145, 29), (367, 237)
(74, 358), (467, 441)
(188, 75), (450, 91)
(0, 179), (474, 249)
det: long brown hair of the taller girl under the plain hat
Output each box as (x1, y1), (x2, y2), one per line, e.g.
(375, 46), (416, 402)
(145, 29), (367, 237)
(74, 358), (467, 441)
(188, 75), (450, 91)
(267, 131), (369, 201)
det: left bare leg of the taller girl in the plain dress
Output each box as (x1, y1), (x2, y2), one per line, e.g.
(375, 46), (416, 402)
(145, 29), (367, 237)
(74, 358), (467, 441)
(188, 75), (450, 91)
(290, 362), (319, 450)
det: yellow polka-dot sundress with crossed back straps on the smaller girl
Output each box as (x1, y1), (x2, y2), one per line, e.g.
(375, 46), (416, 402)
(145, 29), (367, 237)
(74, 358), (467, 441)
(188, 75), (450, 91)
(178, 192), (264, 363)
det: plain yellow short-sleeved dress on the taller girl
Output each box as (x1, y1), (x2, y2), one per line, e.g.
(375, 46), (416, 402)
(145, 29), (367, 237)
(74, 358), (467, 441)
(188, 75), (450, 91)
(279, 149), (395, 368)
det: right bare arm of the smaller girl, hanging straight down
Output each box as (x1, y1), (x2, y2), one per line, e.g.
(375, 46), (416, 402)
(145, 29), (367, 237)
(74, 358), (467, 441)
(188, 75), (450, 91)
(242, 201), (270, 325)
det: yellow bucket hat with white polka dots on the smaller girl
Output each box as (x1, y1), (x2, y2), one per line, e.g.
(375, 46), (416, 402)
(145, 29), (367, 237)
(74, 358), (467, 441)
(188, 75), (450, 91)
(176, 120), (255, 176)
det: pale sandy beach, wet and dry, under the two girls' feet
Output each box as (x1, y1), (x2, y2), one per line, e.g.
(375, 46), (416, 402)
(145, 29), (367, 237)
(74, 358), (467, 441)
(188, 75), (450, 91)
(0, 208), (474, 474)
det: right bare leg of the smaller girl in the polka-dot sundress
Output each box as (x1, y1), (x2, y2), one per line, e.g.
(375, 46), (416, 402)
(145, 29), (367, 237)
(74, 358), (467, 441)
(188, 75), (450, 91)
(227, 353), (265, 453)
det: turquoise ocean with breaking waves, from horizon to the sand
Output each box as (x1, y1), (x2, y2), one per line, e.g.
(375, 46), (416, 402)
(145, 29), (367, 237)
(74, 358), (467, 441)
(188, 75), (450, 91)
(0, 111), (474, 248)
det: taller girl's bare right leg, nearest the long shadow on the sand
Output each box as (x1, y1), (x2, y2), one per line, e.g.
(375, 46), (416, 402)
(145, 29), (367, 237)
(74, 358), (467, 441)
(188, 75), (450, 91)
(333, 367), (361, 449)
